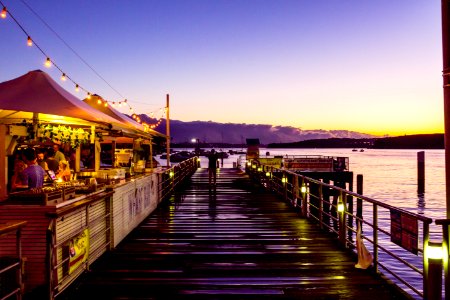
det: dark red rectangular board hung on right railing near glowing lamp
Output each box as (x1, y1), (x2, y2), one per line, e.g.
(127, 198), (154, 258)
(391, 209), (419, 255)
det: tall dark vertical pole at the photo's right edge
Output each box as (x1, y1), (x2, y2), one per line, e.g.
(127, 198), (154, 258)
(441, 0), (450, 218)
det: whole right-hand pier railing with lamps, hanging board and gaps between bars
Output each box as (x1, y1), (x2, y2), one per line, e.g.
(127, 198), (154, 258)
(246, 160), (436, 299)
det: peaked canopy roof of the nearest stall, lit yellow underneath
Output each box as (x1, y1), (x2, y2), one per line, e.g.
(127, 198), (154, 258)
(0, 70), (124, 127)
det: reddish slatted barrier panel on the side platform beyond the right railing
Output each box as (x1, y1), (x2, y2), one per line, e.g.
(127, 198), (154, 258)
(284, 157), (333, 172)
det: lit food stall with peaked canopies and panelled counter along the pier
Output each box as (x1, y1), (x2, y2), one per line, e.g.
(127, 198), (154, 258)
(0, 70), (172, 297)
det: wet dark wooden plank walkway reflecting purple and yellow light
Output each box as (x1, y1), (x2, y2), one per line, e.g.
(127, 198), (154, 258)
(58, 169), (407, 300)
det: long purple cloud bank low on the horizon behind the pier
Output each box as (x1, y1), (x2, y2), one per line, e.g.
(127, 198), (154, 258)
(136, 115), (372, 145)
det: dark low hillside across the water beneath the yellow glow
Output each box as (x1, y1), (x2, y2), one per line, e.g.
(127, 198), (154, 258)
(268, 133), (444, 149)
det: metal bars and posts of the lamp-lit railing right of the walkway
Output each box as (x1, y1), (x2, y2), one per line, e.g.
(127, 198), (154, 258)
(246, 160), (438, 297)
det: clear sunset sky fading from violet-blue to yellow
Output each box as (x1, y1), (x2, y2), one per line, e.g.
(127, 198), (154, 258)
(0, 0), (443, 135)
